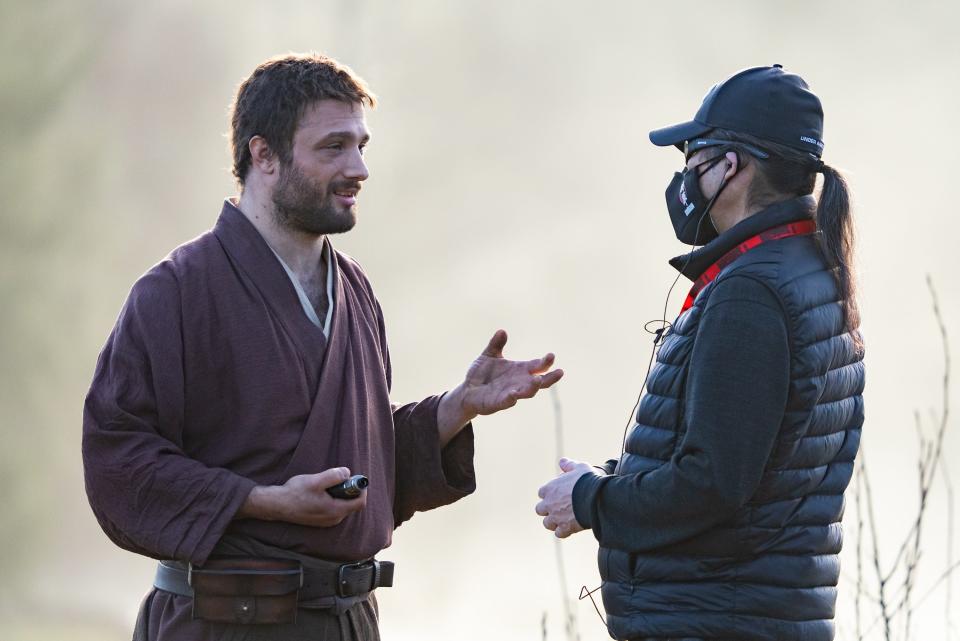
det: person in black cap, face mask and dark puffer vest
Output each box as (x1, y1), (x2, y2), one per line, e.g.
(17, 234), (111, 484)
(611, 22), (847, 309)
(536, 65), (864, 641)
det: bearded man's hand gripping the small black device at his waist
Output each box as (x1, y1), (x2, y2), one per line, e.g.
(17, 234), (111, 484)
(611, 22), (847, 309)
(237, 467), (367, 527)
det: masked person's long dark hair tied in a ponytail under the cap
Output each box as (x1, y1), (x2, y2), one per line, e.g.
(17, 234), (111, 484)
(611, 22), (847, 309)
(710, 129), (862, 340)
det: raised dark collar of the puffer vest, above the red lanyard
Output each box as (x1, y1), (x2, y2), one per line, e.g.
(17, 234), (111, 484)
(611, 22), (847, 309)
(670, 196), (817, 280)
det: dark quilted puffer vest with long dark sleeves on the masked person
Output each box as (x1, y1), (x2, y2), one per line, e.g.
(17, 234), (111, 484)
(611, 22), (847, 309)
(574, 197), (864, 641)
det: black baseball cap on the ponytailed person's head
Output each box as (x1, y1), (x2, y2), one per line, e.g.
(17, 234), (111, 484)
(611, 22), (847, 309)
(650, 65), (823, 158)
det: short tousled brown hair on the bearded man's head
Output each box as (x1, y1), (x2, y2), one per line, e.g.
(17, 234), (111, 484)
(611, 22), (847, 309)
(230, 53), (377, 188)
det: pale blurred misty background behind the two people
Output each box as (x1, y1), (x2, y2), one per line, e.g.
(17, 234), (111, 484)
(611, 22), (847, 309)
(0, 0), (960, 640)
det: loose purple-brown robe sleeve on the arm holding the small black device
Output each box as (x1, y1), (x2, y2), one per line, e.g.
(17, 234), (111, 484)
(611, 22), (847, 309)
(82, 261), (255, 564)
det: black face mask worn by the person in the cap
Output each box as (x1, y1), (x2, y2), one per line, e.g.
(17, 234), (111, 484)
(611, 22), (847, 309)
(665, 154), (727, 245)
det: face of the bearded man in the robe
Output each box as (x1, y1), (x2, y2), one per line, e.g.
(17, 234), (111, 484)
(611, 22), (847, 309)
(273, 100), (370, 235)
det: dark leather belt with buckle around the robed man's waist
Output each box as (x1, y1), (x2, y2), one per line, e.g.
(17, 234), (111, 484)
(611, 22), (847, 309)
(153, 559), (393, 601)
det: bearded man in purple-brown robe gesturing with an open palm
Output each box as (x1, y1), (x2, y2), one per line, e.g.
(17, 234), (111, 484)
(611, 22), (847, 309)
(83, 55), (563, 640)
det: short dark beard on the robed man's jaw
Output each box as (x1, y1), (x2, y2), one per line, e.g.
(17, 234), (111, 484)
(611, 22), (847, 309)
(272, 161), (360, 236)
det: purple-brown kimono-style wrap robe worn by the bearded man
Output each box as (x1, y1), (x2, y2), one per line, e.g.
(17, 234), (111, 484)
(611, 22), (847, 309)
(83, 202), (475, 636)
